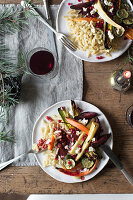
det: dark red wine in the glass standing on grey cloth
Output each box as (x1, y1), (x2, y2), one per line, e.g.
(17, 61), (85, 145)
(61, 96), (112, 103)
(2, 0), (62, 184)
(30, 50), (54, 75)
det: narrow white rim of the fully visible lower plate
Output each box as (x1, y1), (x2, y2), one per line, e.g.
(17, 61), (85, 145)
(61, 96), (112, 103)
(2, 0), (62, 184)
(32, 99), (113, 183)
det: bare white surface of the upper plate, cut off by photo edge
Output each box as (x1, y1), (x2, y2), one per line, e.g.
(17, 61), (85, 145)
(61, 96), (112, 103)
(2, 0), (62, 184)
(56, 0), (133, 62)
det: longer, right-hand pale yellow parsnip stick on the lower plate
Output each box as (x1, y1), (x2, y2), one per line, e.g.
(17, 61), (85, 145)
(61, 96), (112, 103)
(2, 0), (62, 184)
(75, 122), (99, 161)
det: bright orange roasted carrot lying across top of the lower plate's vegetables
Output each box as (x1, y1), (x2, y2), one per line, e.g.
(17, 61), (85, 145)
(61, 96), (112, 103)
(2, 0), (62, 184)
(66, 117), (89, 135)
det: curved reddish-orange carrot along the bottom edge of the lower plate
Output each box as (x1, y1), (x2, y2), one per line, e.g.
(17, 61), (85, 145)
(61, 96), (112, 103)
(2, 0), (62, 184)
(58, 160), (98, 176)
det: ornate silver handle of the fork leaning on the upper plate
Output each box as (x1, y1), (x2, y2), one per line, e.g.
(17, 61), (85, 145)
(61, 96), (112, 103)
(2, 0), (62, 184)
(21, 1), (57, 34)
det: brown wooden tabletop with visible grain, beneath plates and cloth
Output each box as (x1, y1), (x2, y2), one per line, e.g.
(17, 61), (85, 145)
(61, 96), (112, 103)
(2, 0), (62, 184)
(0, 0), (133, 200)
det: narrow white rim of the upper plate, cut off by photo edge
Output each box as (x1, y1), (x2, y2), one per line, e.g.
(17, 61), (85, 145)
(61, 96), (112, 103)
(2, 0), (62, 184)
(56, 0), (133, 63)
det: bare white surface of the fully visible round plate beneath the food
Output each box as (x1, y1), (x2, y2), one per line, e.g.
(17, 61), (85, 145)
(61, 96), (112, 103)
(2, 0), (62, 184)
(32, 100), (113, 183)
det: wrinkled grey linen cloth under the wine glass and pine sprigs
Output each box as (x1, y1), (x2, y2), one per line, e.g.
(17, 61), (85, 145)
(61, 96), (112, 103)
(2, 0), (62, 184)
(0, 5), (83, 166)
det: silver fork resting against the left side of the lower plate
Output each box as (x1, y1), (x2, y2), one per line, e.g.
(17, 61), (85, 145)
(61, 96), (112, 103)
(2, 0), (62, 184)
(0, 149), (41, 170)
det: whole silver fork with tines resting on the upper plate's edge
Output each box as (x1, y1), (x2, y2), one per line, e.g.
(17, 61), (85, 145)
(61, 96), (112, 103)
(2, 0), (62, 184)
(21, 1), (77, 51)
